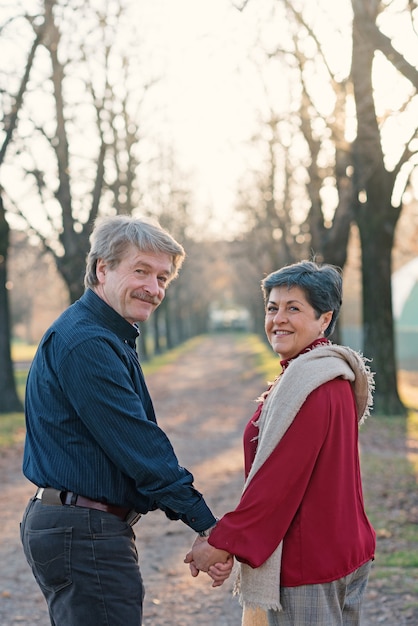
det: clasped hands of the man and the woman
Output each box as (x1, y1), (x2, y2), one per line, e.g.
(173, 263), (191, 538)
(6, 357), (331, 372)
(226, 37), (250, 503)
(184, 537), (234, 587)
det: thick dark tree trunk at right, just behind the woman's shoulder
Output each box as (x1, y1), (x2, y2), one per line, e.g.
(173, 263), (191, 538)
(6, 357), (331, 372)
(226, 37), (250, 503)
(351, 0), (405, 415)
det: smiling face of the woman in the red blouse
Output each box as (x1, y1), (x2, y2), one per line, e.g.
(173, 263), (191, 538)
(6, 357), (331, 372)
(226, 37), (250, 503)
(264, 287), (332, 359)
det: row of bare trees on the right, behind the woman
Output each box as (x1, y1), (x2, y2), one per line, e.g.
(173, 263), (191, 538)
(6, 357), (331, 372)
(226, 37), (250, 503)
(233, 0), (418, 414)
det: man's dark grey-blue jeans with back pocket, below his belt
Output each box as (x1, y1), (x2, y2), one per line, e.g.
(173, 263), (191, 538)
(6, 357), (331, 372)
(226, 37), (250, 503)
(21, 498), (144, 626)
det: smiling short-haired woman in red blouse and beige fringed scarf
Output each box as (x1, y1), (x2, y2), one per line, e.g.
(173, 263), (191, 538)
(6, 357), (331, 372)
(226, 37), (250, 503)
(186, 261), (375, 626)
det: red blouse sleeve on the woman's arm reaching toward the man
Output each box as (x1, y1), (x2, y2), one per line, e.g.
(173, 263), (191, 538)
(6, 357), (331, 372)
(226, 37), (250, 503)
(209, 381), (332, 567)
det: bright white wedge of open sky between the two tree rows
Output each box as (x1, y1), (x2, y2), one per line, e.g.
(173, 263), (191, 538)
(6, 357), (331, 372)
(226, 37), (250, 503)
(129, 0), (259, 234)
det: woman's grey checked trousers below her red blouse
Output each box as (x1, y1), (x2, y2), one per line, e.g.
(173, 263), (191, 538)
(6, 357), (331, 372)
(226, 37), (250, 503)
(267, 561), (372, 626)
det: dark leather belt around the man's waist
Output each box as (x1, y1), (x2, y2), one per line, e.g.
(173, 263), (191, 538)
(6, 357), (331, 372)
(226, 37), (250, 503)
(35, 487), (141, 526)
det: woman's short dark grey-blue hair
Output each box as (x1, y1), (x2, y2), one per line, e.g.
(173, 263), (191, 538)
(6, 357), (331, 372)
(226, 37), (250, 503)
(261, 261), (342, 337)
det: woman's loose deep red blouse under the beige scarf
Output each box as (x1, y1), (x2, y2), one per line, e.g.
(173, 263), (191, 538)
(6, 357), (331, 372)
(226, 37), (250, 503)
(209, 338), (376, 587)
